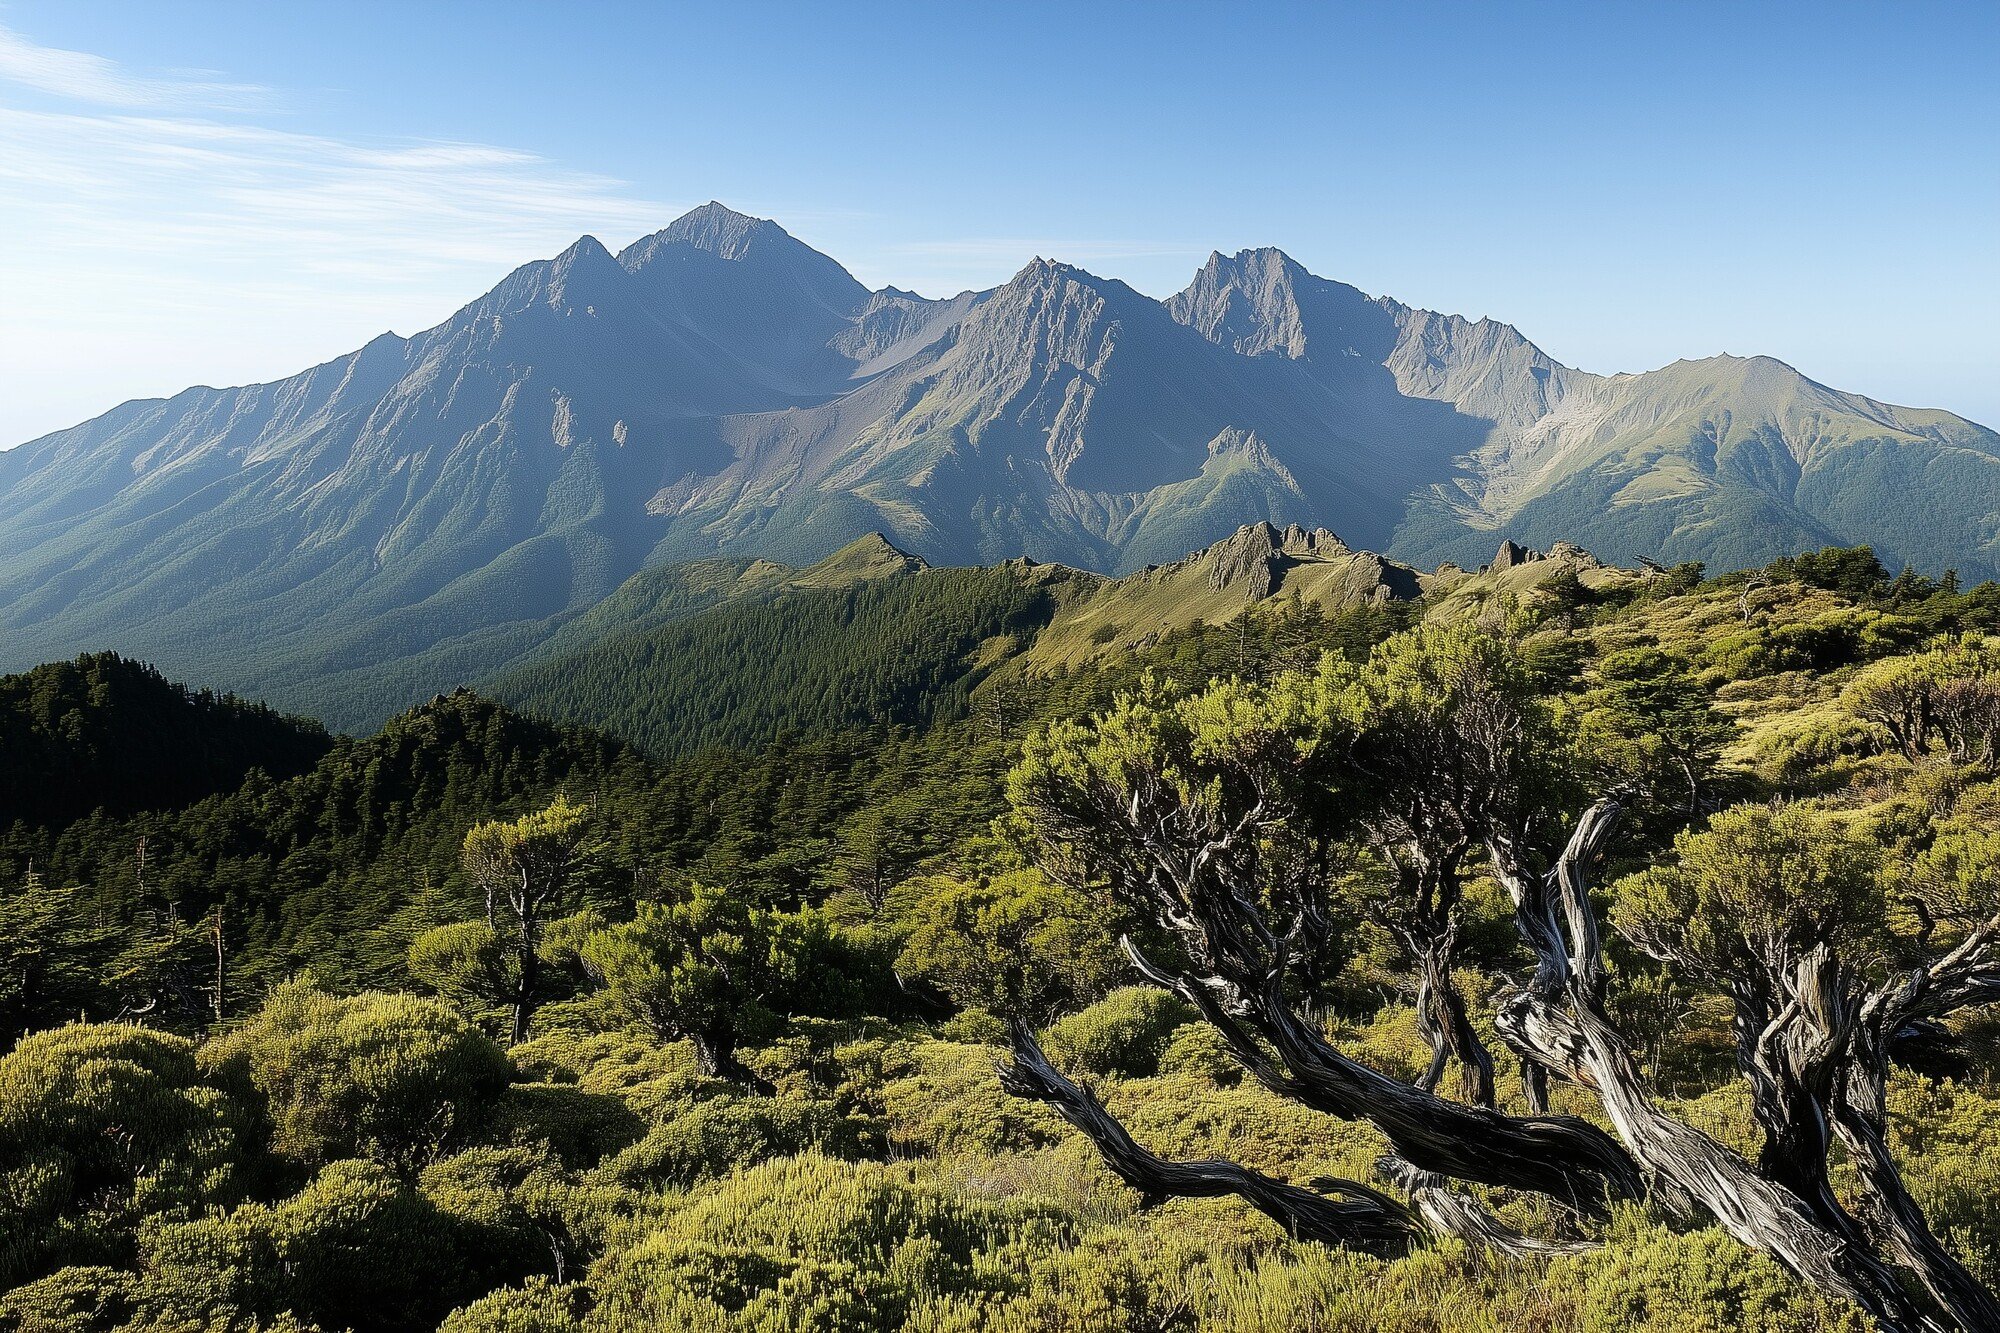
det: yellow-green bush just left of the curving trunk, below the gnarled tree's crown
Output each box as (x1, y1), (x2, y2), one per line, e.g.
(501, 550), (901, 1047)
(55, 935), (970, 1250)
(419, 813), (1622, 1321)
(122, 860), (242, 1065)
(896, 871), (1126, 1023)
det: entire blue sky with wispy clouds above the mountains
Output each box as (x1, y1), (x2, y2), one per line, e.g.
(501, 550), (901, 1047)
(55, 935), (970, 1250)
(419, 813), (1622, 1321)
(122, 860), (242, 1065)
(0, 0), (2000, 444)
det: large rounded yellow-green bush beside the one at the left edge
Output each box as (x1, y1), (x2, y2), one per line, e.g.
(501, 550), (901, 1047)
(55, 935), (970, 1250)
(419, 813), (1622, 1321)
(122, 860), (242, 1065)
(202, 979), (512, 1171)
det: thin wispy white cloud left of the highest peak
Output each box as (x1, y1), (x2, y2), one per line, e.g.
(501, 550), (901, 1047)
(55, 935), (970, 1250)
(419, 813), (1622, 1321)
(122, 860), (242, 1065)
(0, 28), (684, 448)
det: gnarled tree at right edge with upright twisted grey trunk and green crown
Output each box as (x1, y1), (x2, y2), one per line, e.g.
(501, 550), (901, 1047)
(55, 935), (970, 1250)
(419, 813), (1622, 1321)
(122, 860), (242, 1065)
(1618, 807), (2000, 1329)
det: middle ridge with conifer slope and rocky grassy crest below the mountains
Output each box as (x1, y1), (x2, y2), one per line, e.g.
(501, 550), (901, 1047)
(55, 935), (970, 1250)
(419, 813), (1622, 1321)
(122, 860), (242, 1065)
(482, 522), (1654, 755)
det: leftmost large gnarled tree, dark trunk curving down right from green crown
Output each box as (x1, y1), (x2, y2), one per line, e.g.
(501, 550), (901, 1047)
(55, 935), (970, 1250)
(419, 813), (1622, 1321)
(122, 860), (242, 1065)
(1012, 652), (1644, 1211)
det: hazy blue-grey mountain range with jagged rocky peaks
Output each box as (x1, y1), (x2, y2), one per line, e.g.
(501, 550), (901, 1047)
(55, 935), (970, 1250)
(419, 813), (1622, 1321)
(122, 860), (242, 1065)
(0, 204), (2000, 725)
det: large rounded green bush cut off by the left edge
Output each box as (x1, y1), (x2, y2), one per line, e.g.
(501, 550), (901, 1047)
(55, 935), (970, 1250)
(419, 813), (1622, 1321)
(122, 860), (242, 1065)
(0, 1023), (250, 1289)
